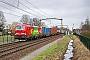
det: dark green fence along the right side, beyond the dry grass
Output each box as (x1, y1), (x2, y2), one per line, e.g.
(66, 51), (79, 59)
(73, 33), (90, 50)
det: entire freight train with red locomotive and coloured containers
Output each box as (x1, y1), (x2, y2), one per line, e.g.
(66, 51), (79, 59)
(14, 24), (65, 41)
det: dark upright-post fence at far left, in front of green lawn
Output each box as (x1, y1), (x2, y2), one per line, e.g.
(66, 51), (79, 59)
(0, 35), (15, 45)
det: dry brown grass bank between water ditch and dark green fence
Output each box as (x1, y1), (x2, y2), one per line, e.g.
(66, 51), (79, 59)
(72, 37), (90, 60)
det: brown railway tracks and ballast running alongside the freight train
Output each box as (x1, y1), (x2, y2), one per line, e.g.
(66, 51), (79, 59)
(0, 35), (61, 60)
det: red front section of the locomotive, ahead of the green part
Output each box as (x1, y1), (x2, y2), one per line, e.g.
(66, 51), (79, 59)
(14, 24), (34, 40)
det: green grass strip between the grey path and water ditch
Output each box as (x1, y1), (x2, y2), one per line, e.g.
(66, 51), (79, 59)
(34, 35), (73, 60)
